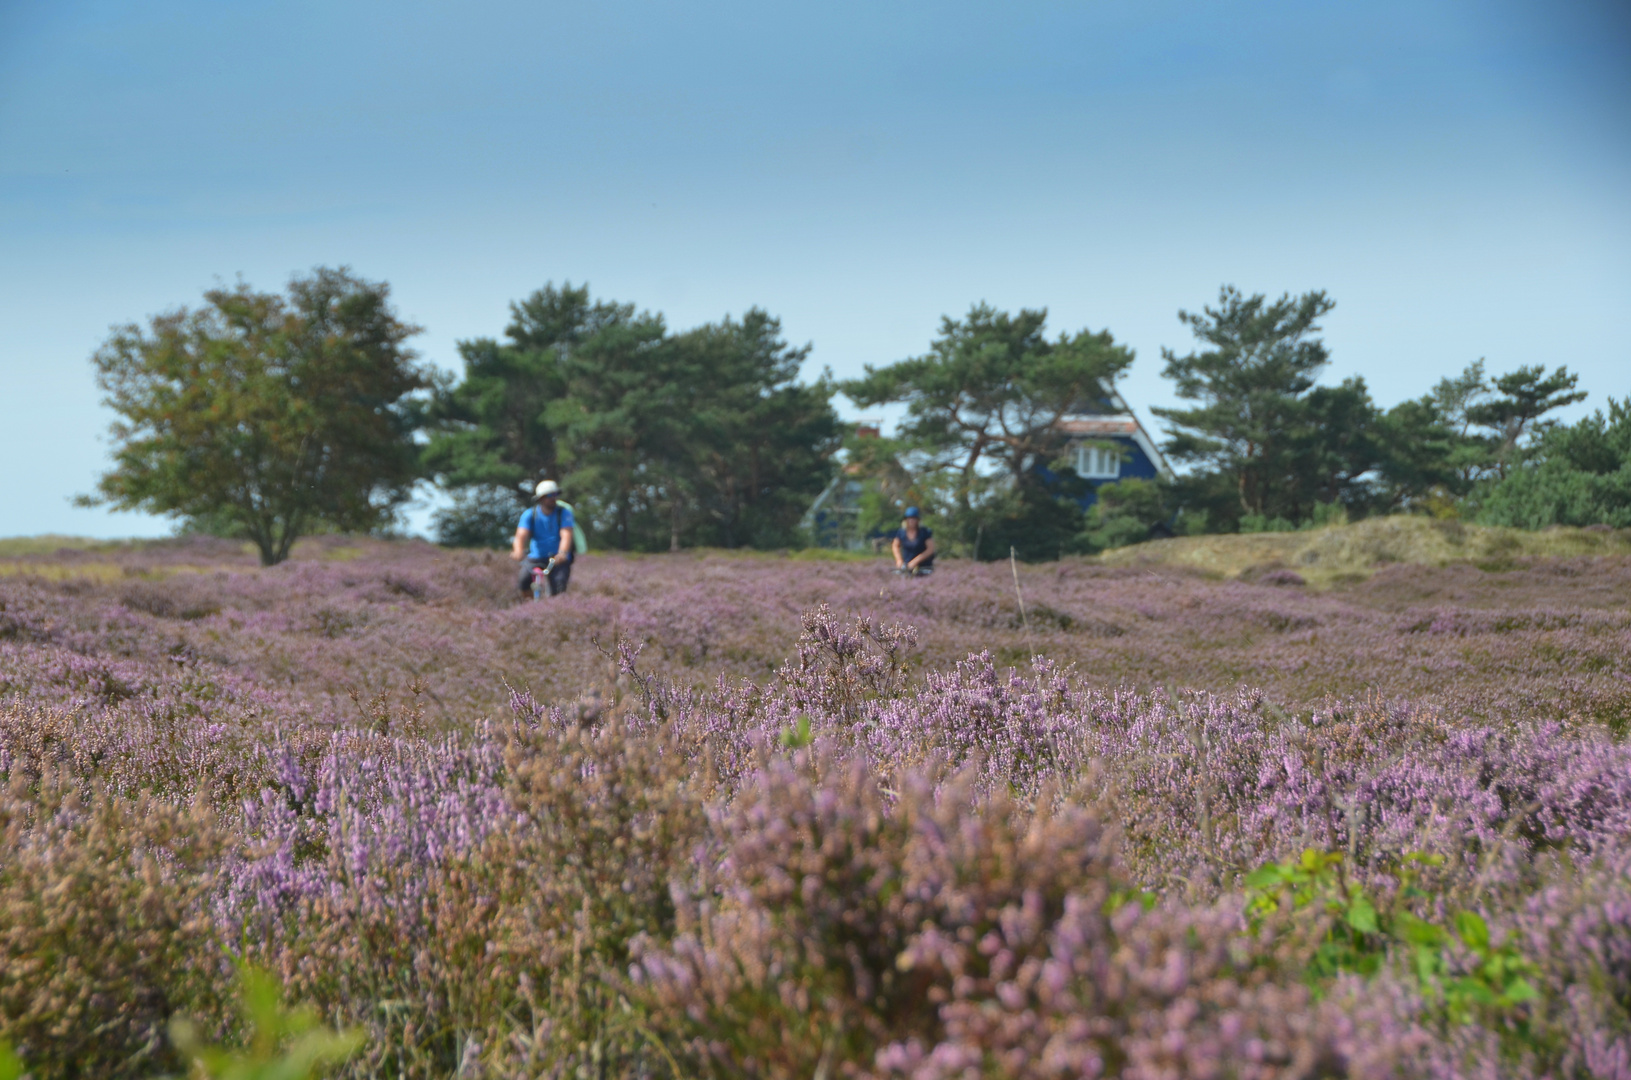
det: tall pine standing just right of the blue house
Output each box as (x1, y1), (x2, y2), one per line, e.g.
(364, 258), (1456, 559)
(1153, 285), (1336, 517)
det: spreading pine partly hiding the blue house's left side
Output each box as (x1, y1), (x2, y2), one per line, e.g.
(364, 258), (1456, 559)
(840, 303), (1134, 558)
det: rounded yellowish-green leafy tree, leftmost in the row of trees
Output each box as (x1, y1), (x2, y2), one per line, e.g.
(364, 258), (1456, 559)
(85, 268), (429, 566)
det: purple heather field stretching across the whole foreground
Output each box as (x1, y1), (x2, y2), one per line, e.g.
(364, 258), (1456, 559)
(0, 537), (1631, 1080)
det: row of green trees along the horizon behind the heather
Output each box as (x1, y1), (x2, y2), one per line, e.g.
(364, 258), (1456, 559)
(80, 268), (1631, 564)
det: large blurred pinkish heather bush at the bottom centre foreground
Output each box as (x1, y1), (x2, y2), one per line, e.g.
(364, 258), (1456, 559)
(634, 750), (1336, 1080)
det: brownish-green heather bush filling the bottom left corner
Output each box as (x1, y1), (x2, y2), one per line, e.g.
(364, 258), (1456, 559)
(0, 777), (228, 1080)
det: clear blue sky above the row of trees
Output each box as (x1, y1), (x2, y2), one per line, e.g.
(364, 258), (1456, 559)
(0, 0), (1631, 537)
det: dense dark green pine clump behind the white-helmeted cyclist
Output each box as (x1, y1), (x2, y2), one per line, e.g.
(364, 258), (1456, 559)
(426, 284), (838, 550)
